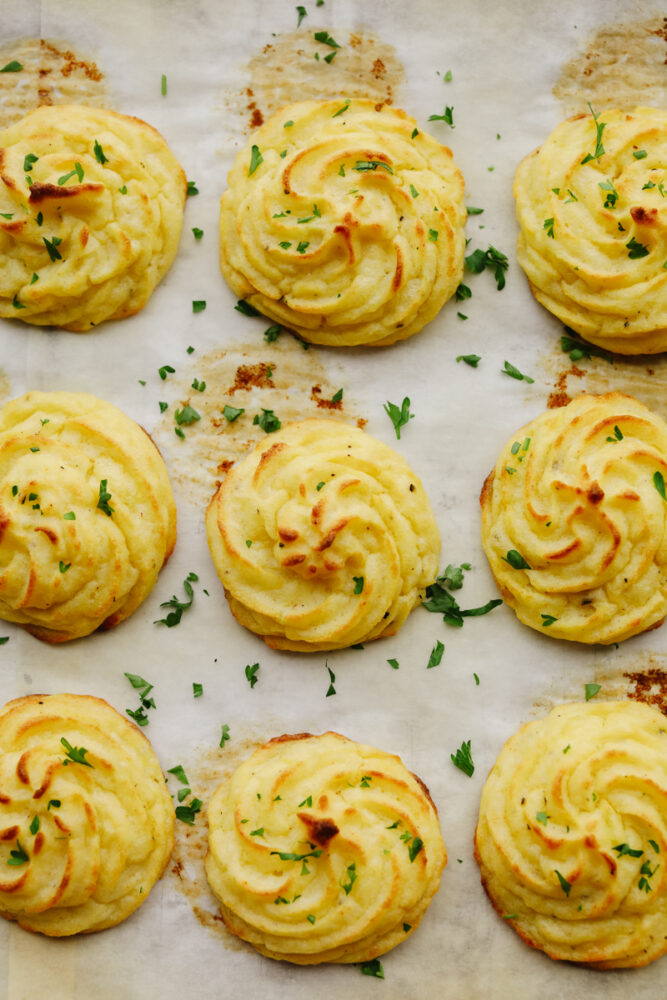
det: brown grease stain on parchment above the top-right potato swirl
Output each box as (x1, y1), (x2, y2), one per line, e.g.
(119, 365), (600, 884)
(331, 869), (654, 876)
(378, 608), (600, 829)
(553, 14), (667, 115)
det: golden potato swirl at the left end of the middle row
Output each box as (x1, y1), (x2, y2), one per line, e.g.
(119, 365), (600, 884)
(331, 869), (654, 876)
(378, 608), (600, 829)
(0, 392), (176, 643)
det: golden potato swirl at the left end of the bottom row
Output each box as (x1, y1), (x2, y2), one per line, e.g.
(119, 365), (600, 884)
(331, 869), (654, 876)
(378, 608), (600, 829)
(0, 694), (174, 937)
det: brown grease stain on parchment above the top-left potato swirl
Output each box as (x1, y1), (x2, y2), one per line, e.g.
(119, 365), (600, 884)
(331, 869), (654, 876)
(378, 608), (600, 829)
(0, 38), (109, 128)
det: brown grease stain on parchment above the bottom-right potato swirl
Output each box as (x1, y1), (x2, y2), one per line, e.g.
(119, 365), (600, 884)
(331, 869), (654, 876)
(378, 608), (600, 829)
(531, 652), (667, 718)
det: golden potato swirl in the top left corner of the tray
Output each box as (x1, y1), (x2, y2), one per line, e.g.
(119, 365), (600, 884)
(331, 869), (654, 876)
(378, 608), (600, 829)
(0, 104), (187, 333)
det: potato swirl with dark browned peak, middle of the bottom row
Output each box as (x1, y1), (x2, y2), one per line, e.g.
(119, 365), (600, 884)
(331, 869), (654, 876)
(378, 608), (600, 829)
(206, 733), (447, 965)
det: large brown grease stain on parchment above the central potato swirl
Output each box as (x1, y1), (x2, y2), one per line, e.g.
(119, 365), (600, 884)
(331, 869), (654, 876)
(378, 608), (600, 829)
(152, 334), (366, 507)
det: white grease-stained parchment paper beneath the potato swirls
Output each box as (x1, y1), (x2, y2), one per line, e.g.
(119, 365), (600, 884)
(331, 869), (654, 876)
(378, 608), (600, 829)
(0, 0), (667, 1000)
